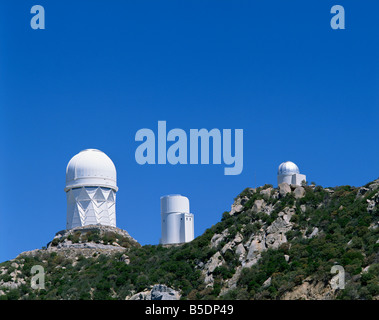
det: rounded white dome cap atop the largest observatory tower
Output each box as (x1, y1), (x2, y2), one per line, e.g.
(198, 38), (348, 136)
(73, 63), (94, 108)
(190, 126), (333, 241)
(65, 149), (118, 191)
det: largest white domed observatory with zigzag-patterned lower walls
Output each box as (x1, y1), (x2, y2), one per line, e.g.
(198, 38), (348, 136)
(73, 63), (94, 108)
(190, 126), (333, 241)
(64, 149), (118, 229)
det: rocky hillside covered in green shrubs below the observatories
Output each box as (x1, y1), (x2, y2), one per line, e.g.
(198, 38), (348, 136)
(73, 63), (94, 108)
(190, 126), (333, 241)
(0, 180), (379, 300)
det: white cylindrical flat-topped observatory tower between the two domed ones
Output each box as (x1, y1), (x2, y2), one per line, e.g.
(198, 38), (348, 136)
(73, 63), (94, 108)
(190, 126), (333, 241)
(160, 194), (194, 244)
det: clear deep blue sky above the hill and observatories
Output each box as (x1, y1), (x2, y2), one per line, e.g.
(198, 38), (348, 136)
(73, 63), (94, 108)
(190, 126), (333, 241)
(0, 0), (379, 261)
